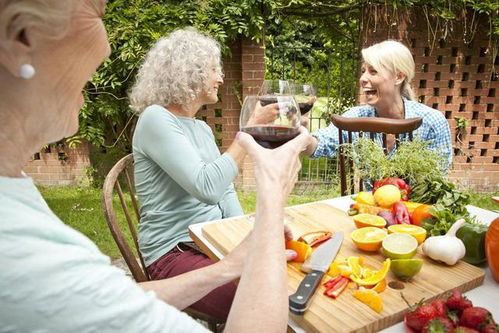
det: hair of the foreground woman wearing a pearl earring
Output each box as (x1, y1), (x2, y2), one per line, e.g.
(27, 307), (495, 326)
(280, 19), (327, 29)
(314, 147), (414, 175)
(0, 0), (78, 39)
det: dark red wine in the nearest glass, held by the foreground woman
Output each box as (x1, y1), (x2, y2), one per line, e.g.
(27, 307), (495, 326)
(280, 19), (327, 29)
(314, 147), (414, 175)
(242, 125), (299, 149)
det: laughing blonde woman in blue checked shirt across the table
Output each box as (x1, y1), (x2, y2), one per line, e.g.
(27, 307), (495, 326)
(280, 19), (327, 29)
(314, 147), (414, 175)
(305, 40), (452, 167)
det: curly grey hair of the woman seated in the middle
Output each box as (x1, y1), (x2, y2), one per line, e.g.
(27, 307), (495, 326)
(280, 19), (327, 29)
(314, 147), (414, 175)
(129, 28), (223, 113)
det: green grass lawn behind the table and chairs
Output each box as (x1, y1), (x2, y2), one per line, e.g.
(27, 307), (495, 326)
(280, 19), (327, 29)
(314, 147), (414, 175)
(40, 186), (499, 259)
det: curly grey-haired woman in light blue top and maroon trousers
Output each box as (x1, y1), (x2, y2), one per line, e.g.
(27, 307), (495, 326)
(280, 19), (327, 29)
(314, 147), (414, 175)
(130, 28), (286, 320)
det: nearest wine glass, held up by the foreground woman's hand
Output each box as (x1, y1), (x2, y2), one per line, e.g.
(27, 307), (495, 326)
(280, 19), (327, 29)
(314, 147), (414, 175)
(239, 95), (300, 149)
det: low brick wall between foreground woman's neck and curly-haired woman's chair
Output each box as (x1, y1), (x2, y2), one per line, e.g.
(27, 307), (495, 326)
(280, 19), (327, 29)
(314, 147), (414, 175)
(24, 142), (90, 186)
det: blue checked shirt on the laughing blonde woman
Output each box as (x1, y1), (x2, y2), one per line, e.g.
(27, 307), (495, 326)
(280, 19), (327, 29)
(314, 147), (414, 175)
(311, 99), (452, 170)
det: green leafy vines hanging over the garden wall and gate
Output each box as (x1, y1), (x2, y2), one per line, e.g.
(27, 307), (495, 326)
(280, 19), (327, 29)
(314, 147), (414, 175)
(76, 0), (499, 152)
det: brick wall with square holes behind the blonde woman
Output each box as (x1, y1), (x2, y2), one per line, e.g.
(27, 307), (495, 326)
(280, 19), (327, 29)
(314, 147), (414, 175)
(361, 7), (499, 192)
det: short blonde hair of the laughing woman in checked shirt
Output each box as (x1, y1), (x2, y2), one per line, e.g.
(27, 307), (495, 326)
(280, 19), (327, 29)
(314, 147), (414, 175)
(362, 40), (416, 100)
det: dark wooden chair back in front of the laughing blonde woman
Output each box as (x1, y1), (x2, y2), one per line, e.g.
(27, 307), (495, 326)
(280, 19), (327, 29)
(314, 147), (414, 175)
(331, 114), (423, 196)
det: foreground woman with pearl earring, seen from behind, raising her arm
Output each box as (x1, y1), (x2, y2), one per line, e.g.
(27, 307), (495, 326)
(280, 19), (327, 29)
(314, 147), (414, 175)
(0, 0), (310, 333)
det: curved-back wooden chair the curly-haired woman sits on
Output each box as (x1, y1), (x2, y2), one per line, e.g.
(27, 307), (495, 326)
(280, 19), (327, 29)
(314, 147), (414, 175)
(102, 154), (223, 332)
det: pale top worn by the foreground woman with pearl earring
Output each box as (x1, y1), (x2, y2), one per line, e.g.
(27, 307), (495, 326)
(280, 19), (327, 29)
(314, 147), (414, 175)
(0, 177), (207, 333)
